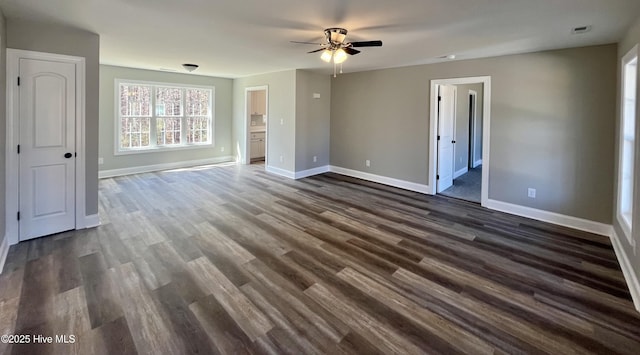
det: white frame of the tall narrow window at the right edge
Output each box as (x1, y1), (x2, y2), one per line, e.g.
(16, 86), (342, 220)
(615, 45), (640, 246)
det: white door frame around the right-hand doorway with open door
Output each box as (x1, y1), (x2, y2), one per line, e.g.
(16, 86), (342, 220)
(429, 76), (491, 206)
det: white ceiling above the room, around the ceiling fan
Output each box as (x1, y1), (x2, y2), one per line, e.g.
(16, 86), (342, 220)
(0, 0), (640, 78)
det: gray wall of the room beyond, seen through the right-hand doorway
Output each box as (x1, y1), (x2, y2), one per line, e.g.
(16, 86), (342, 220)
(454, 84), (483, 171)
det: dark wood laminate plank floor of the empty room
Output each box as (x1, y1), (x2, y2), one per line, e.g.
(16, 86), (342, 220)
(0, 165), (640, 354)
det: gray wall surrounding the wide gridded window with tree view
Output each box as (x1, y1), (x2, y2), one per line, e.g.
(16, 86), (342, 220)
(99, 65), (233, 170)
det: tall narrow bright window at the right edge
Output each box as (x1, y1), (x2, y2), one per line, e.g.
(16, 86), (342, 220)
(617, 48), (638, 237)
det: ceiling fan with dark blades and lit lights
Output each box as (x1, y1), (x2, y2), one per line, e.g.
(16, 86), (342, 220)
(291, 27), (382, 76)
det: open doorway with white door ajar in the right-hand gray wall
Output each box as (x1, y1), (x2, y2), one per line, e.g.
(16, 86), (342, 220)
(429, 77), (491, 204)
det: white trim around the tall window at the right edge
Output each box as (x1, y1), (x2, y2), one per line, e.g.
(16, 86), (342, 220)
(615, 45), (640, 248)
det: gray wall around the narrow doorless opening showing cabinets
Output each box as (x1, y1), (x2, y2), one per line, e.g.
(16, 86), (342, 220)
(232, 70), (296, 172)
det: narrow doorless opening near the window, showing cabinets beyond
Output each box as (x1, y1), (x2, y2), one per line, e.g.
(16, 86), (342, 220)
(244, 86), (269, 165)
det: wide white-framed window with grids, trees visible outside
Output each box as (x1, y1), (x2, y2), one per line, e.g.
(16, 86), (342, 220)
(116, 80), (214, 153)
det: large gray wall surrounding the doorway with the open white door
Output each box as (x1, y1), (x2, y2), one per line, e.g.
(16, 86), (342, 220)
(331, 45), (617, 223)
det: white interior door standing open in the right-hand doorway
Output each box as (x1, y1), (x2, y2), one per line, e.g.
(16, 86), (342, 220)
(437, 85), (456, 192)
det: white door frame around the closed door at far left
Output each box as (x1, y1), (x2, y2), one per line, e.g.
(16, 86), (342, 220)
(5, 48), (87, 245)
